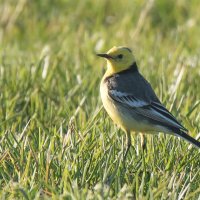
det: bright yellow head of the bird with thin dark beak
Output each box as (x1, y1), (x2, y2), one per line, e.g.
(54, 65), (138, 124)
(97, 47), (135, 74)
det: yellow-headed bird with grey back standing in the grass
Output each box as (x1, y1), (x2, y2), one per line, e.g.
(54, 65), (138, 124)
(97, 46), (200, 158)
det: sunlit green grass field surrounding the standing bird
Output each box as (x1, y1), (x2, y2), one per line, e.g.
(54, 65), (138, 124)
(0, 0), (200, 199)
